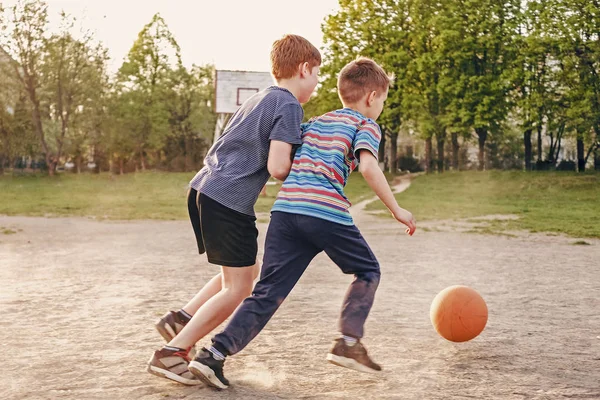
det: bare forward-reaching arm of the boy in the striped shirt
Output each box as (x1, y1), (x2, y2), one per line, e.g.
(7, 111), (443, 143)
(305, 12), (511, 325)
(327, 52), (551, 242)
(358, 150), (417, 236)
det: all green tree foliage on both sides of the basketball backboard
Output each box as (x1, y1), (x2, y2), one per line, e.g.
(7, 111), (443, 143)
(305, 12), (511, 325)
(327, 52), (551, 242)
(0, 0), (600, 171)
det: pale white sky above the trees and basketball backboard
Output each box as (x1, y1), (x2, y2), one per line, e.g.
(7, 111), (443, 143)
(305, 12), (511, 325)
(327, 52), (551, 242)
(0, 0), (338, 72)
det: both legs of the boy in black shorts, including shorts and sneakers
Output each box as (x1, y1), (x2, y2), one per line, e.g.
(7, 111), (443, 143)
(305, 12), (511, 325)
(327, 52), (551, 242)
(148, 191), (259, 384)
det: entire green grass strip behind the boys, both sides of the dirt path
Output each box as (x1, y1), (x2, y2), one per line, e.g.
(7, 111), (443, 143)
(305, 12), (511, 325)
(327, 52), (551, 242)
(0, 171), (600, 238)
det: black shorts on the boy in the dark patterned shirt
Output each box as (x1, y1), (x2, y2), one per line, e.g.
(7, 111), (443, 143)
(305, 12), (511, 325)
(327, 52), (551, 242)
(188, 188), (258, 267)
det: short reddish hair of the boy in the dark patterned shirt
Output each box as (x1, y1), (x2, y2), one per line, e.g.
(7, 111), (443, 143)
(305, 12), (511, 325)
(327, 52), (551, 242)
(271, 34), (321, 80)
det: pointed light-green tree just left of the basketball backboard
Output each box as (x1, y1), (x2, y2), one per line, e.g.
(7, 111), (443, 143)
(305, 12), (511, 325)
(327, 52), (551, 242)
(110, 14), (216, 170)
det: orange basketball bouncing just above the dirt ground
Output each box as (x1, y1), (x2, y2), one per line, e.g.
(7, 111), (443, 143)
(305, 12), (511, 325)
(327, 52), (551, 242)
(429, 286), (487, 342)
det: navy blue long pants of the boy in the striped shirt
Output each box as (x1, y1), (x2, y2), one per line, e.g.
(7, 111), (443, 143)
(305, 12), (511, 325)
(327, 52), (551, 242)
(213, 212), (380, 355)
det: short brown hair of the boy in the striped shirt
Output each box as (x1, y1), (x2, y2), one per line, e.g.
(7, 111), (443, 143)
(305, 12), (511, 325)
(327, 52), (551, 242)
(338, 57), (392, 104)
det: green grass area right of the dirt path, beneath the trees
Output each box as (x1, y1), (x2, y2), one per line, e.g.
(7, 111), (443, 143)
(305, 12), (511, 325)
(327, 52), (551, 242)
(367, 171), (600, 238)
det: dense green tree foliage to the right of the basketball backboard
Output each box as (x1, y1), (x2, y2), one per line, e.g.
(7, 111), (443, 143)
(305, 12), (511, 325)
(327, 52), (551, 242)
(314, 0), (600, 172)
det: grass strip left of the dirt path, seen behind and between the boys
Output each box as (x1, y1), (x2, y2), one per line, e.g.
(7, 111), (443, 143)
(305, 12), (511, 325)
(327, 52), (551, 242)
(0, 172), (392, 220)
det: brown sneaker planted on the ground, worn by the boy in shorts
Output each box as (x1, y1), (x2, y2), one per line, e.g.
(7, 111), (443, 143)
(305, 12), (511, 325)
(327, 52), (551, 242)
(146, 347), (202, 386)
